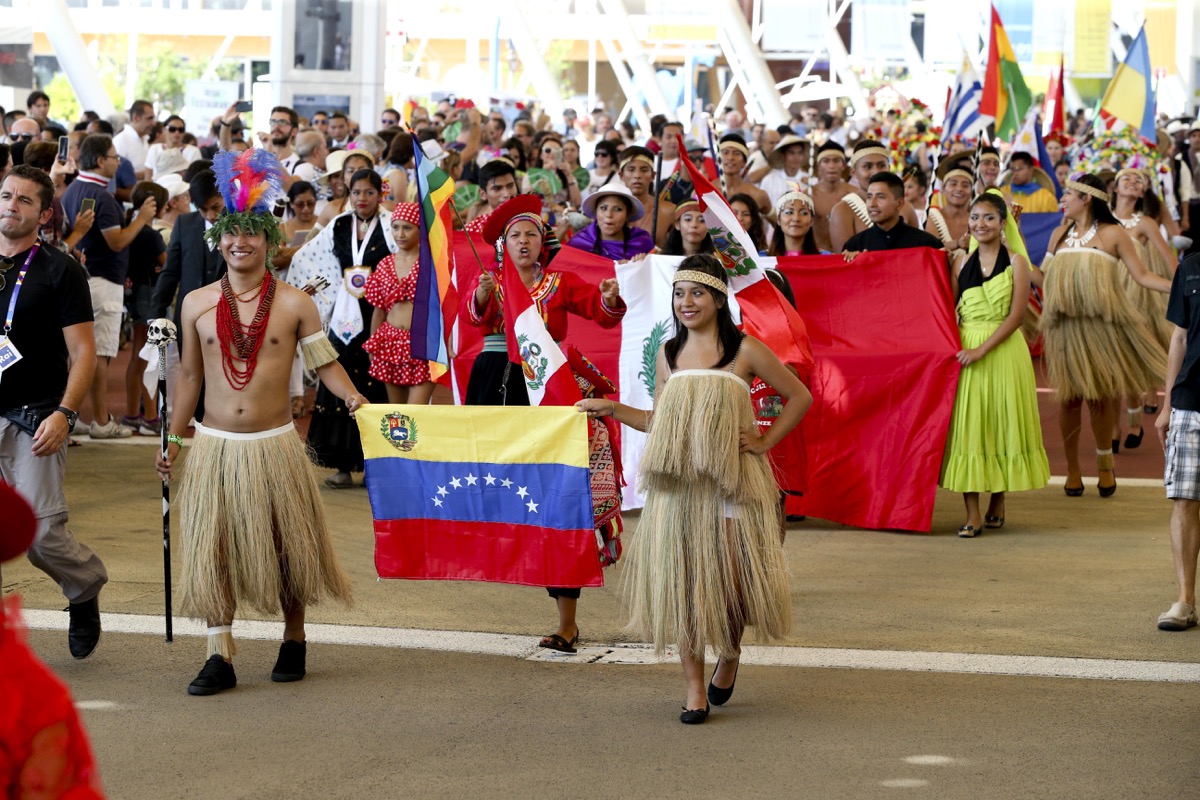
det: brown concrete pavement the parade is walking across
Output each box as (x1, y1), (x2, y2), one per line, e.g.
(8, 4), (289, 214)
(4, 443), (1200, 799)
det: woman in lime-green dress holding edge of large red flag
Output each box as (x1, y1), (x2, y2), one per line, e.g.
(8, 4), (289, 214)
(941, 194), (1050, 539)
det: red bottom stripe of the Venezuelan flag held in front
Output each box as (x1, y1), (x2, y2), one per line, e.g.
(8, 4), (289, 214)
(374, 519), (604, 587)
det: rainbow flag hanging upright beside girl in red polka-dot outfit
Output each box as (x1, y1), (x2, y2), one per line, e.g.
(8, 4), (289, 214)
(412, 148), (458, 380)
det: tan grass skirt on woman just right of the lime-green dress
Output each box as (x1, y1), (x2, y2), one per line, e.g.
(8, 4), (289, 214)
(1042, 247), (1166, 401)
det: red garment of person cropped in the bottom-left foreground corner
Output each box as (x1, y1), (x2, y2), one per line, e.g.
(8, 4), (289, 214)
(0, 597), (104, 800)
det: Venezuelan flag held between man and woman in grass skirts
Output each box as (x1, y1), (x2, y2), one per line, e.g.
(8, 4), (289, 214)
(354, 405), (604, 587)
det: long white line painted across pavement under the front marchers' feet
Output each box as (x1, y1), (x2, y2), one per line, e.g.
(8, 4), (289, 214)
(22, 608), (1200, 684)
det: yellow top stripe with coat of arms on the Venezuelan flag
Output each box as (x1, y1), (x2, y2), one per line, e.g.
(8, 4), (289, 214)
(354, 404), (588, 468)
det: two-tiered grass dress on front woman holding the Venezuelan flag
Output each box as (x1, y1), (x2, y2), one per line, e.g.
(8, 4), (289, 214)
(625, 369), (792, 658)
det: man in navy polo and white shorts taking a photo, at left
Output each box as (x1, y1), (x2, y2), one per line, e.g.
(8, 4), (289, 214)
(62, 133), (158, 439)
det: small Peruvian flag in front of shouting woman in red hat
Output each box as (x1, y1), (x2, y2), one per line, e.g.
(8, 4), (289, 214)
(502, 258), (582, 405)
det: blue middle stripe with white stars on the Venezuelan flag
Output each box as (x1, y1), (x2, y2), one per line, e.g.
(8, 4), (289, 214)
(366, 458), (594, 530)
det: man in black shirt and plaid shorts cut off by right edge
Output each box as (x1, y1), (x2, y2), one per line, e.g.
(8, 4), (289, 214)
(1154, 254), (1200, 631)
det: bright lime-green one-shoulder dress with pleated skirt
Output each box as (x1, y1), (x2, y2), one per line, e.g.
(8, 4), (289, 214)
(938, 270), (1050, 492)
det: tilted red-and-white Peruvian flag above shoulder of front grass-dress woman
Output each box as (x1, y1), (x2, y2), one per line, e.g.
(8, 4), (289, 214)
(679, 131), (812, 380)
